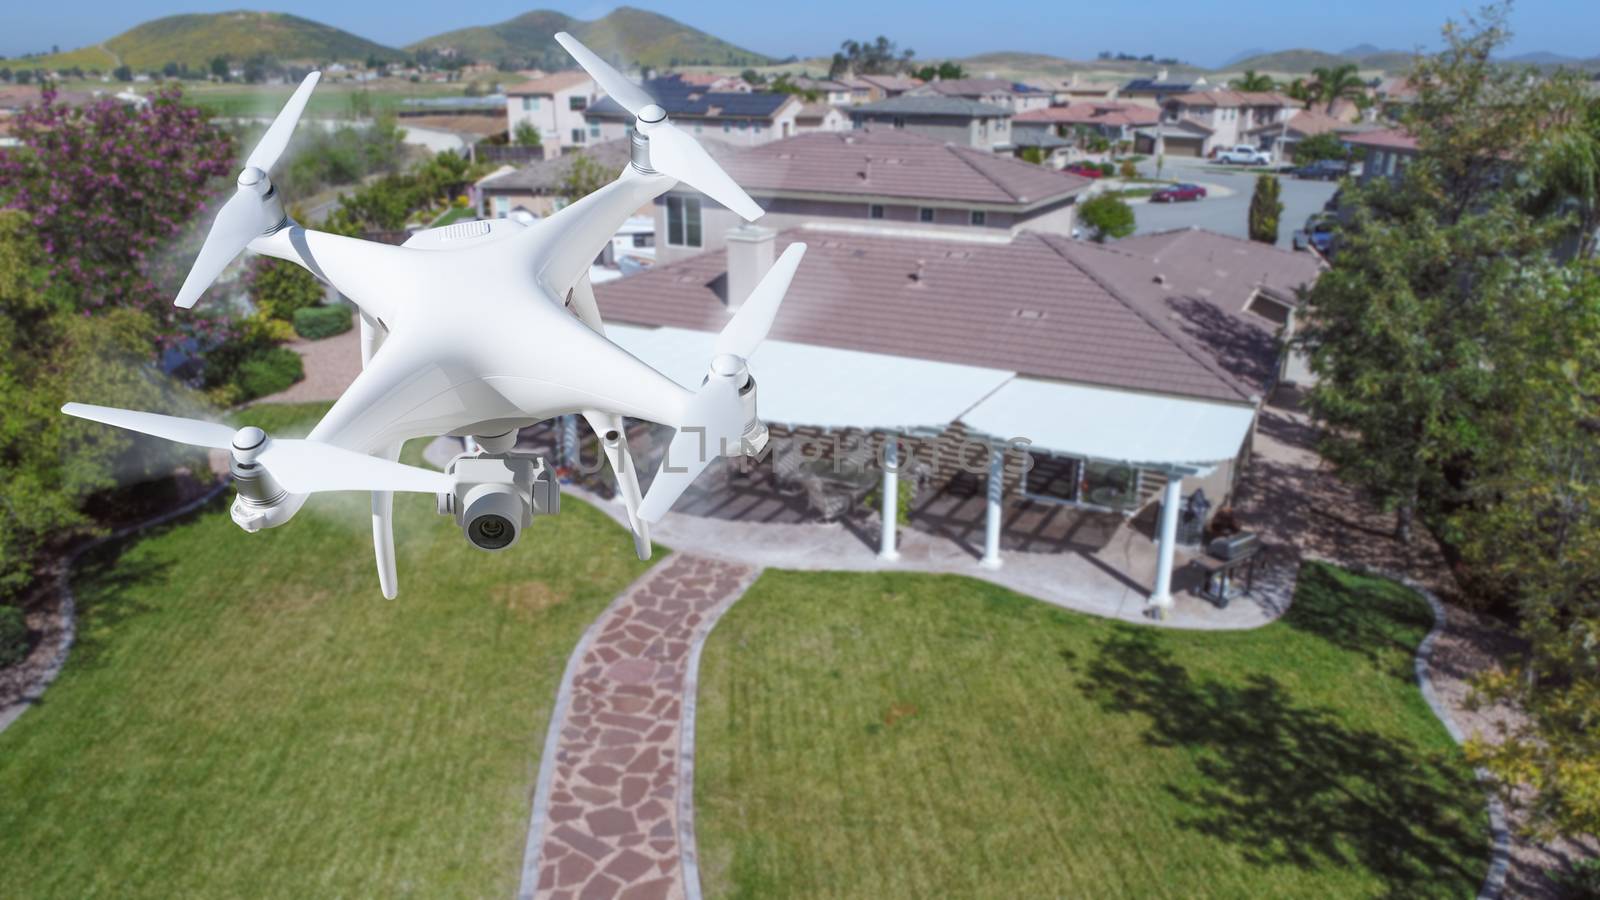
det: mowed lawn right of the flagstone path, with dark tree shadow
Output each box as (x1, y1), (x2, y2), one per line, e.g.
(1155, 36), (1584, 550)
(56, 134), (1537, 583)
(694, 565), (1488, 898)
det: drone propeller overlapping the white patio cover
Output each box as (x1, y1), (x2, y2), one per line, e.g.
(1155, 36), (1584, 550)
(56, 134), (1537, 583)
(638, 242), (805, 522)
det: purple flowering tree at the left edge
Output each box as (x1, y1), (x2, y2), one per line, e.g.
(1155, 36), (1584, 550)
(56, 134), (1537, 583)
(0, 86), (234, 340)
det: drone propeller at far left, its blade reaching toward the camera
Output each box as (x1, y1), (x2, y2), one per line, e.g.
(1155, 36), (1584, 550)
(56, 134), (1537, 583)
(61, 404), (454, 493)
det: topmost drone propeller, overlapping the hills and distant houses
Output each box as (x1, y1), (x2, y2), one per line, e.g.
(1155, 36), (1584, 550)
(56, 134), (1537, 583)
(555, 32), (763, 223)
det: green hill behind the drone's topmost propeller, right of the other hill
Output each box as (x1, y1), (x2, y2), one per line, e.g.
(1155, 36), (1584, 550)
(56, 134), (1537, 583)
(410, 6), (771, 69)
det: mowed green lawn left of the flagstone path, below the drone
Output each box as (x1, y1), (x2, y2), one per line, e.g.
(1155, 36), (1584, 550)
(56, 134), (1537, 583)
(0, 407), (646, 898)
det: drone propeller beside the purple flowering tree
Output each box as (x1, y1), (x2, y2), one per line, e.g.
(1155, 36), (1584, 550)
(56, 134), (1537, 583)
(174, 72), (322, 309)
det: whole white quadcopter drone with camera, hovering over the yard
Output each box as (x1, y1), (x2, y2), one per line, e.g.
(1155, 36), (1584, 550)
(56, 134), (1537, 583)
(61, 34), (805, 597)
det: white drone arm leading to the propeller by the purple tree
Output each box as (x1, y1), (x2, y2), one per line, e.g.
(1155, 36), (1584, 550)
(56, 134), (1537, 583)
(250, 223), (411, 325)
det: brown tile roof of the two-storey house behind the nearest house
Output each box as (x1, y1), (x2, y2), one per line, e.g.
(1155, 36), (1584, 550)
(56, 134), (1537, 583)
(723, 130), (1090, 207)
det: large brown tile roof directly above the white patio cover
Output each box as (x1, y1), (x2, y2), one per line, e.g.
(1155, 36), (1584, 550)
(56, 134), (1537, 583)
(595, 229), (1312, 402)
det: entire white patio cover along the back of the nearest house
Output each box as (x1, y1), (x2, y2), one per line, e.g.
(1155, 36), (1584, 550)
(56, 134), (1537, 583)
(606, 325), (1254, 472)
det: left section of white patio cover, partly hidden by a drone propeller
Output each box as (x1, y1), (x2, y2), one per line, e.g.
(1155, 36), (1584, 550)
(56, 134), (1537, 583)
(605, 325), (1016, 431)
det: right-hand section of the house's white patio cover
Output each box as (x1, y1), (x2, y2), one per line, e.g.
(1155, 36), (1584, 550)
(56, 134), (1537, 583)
(962, 378), (1254, 471)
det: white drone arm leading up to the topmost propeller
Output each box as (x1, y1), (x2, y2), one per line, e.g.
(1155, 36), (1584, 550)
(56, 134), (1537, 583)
(524, 165), (677, 296)
